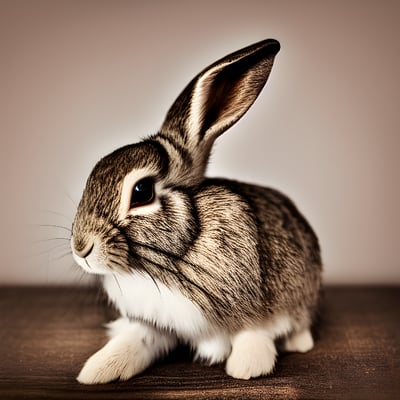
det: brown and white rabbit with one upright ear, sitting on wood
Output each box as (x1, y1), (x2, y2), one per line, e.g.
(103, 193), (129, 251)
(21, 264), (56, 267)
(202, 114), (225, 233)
(71, 39), (322, 384)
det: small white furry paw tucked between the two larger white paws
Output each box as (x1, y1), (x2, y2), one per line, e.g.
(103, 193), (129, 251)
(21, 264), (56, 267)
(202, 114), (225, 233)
(195, 336), (231, 365)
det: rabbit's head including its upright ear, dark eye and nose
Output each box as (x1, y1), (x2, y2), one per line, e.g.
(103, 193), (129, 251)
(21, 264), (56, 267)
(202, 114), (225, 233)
(71, 39), (279, 282)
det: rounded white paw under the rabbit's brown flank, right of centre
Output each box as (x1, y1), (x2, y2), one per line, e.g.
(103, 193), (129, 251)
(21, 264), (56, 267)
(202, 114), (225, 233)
(226, 330), (276, 379)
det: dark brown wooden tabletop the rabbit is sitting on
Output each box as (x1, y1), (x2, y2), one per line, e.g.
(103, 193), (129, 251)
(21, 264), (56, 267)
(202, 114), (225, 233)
(0, 287), (400, 399)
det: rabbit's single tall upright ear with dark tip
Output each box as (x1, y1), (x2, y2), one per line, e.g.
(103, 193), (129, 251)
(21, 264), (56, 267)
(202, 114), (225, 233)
(158, 39), (280, 183)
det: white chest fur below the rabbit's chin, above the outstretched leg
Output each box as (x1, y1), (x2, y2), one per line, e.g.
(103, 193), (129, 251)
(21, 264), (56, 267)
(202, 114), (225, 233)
(103, 272), (213, 341)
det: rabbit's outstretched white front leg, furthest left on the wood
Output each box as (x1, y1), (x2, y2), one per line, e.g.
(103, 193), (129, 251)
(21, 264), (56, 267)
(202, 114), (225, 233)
(77, 318), (176, 384)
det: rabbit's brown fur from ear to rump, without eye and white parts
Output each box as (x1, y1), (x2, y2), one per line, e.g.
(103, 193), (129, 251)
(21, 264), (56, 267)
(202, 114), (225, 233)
(73, 40), (322, 332)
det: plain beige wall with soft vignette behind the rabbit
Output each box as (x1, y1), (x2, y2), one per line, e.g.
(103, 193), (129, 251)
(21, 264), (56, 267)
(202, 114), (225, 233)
(0, 0), (400, 284)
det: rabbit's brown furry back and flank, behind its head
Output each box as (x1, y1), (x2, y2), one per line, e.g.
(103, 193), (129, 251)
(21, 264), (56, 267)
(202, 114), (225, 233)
(188, 179), (322, 330)
